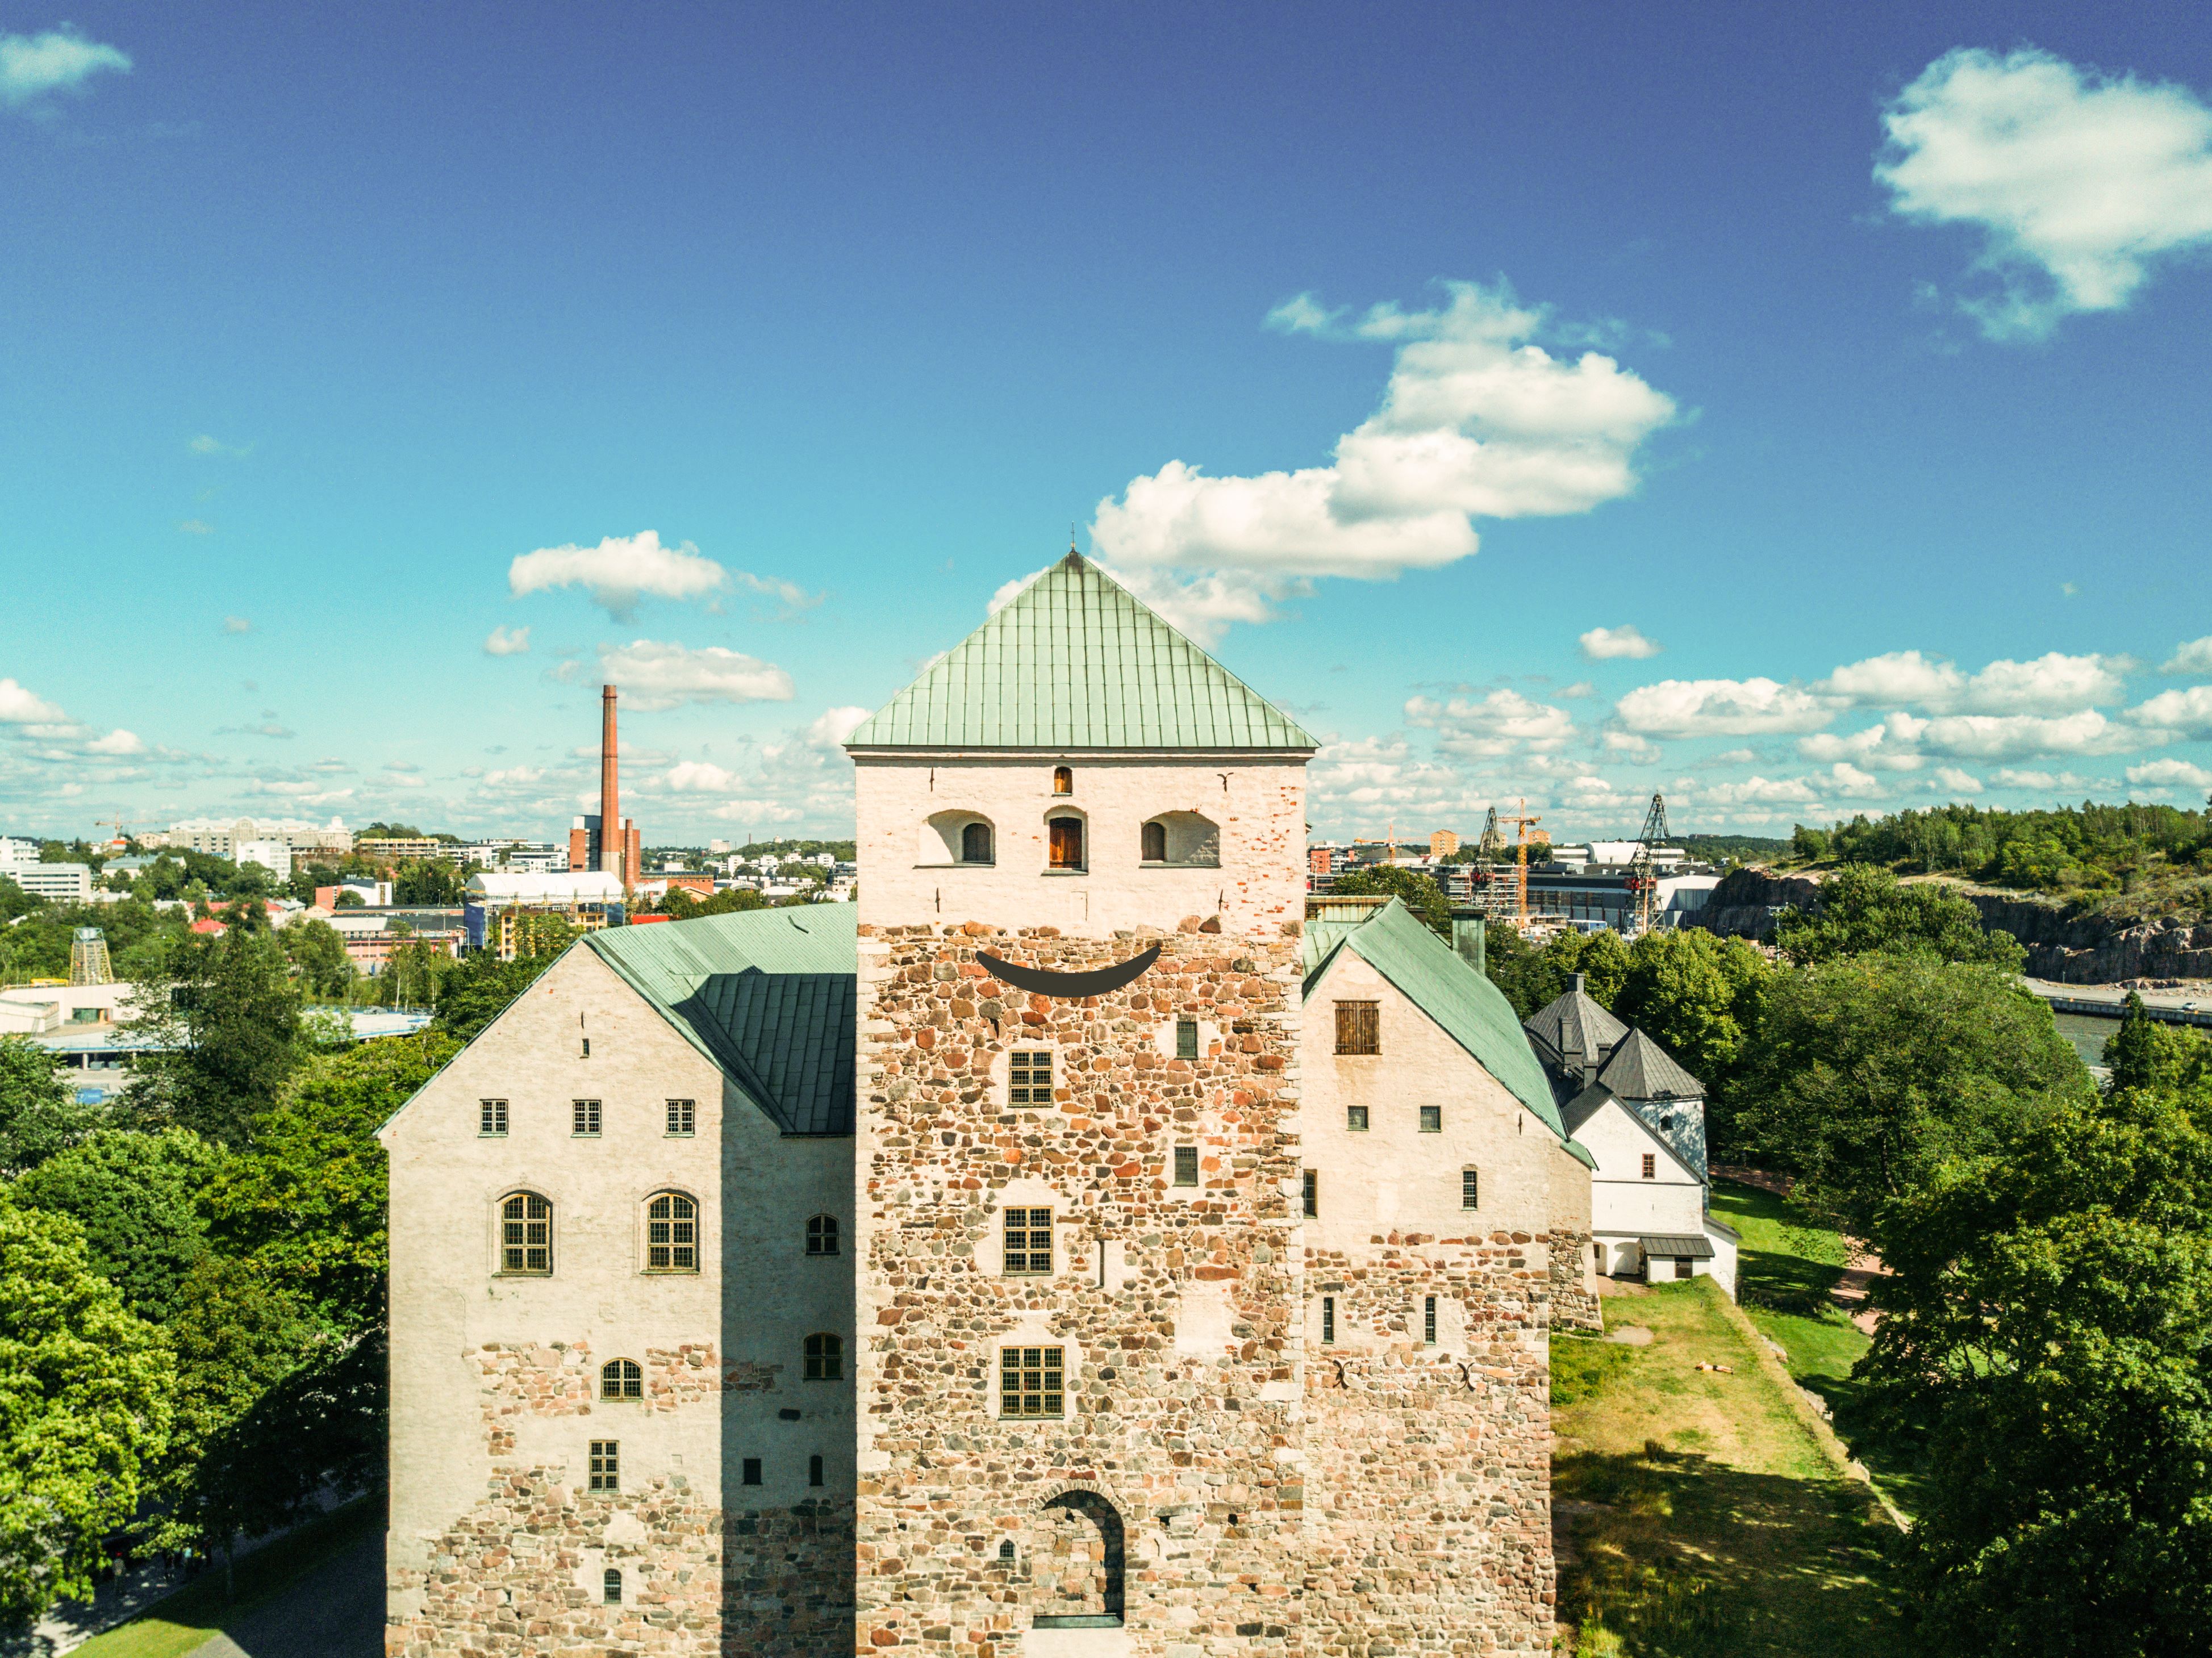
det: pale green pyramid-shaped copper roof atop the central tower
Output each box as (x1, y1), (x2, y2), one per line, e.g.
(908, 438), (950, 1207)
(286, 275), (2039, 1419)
(845, 553), (1321, 751)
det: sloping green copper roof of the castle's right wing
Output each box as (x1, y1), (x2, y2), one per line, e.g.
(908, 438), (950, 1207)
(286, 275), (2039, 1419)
(1305, 897), (1597, 1170)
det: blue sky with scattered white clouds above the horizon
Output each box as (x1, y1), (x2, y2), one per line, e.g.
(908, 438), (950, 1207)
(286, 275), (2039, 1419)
(0, 5), (2212, 842)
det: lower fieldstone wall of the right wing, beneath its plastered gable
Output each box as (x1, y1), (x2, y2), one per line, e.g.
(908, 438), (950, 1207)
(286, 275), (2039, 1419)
(1305, 1234), (1575, 1658)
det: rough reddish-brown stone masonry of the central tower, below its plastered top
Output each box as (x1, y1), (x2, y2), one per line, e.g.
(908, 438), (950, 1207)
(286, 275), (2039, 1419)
(856, 917), (1305, 1658)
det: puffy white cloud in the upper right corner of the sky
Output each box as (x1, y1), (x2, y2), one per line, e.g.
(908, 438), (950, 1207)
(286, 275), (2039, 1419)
(1873, 49), (2212, 340)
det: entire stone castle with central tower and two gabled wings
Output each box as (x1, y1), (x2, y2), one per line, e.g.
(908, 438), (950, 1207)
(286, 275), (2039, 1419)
(383, 553), (1595, 1658)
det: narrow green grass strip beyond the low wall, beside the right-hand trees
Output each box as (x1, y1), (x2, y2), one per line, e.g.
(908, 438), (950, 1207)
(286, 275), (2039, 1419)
(1712, 1180), (1918, 1514)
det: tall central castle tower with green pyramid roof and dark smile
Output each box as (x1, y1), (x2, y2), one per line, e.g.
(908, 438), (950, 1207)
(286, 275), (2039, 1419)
(847, 553), (1316, 1658)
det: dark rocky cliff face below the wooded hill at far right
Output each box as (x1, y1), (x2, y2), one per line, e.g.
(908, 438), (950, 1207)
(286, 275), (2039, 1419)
(1695, 867), (2212, 984)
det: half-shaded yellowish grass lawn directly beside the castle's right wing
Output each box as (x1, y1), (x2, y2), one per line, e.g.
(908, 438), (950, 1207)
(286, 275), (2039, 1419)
(1551, 1278), (1909, 1658)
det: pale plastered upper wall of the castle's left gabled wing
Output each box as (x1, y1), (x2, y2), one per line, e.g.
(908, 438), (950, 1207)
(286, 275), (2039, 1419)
(381, 946), (854, 1600)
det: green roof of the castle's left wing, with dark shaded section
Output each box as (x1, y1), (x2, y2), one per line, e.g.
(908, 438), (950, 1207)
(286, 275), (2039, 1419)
(584, 904), (861, 1134)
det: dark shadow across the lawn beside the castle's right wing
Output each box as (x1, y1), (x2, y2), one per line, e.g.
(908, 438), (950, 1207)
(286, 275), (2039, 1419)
(1553, 1442), (1909, 1658)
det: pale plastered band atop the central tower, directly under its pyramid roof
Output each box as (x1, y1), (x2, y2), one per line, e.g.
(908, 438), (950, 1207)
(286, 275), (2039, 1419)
(854, 749), (1305, 937)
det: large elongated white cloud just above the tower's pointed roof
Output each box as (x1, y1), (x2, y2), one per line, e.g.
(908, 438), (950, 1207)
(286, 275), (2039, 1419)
(1091, 283), (1675, 582)
